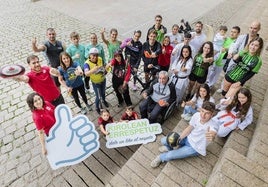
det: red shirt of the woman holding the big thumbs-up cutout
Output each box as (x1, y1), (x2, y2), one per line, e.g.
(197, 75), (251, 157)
(32, 101), (56, 136)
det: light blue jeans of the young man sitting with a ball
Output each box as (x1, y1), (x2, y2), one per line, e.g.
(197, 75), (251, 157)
(160, 137), (199, 162)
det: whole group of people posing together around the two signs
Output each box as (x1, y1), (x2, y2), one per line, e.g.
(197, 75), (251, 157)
(14, 15), (263, 163)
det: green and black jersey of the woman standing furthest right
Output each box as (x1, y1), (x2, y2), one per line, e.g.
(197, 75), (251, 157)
(227, 51), (262, 82)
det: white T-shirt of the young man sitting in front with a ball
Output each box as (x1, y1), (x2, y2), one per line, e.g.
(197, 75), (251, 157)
(187, 112), (218, 156)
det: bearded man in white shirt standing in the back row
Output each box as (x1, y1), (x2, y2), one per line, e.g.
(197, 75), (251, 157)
(190, 21), (207, 54)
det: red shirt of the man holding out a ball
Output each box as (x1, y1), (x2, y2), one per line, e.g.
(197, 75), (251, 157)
(27, 66), (60, 102)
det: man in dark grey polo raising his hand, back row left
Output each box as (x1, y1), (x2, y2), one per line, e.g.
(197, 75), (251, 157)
(32, 28), (65, 87)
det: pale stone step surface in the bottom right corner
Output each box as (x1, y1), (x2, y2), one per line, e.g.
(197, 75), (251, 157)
(206, 148), (268, 187)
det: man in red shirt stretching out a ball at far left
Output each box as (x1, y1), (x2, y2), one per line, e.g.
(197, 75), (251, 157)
(13, 55), (64, 106)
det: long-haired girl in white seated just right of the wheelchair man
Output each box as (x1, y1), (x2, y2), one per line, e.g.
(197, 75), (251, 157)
(181, 84), (215, 121)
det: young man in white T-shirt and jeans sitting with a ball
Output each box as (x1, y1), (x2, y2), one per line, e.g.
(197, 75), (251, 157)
(151, 101), (217, 168)
